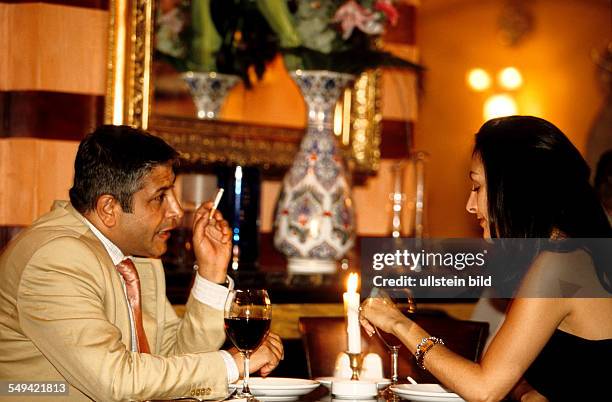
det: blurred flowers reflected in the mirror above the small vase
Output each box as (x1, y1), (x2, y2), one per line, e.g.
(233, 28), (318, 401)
(155, 0), (278, 87)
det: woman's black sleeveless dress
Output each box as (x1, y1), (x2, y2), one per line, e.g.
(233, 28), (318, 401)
(524, 330), (612, 402)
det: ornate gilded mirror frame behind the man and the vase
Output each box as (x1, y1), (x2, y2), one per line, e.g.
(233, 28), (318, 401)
(105, 0), (381, 175)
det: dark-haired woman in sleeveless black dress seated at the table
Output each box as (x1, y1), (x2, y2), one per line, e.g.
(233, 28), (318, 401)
(361, 116), (612, 401)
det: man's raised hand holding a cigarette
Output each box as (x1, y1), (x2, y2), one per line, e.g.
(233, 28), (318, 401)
(193, 201), (232, 283)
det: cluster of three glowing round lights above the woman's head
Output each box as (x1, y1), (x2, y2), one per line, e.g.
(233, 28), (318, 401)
(466, 67), (523, 121)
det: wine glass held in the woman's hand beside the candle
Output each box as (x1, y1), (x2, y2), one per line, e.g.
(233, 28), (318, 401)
(370, 288), (416, 385)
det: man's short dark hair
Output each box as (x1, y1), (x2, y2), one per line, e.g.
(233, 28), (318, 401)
(69, 125), (178, 213)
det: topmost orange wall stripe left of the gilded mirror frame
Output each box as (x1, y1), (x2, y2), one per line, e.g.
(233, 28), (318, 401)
(0, 3), (109, 95)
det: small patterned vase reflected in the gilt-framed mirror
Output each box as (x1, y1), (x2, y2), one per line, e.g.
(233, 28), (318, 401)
(181, 71), (240, 120)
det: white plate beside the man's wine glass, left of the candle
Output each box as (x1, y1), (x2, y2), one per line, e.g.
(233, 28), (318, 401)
(229, 377), (319, 402)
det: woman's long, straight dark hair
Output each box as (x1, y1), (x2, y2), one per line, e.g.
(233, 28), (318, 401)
(473, 116), (612, 291)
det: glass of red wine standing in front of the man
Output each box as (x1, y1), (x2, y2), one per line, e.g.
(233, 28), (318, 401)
(224, 289), (272, 401)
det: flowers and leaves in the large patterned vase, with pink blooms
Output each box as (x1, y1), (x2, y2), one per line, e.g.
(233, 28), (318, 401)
(256, 0), (422, 74)
